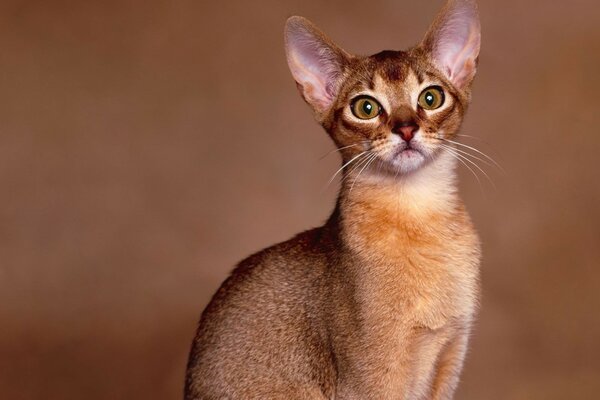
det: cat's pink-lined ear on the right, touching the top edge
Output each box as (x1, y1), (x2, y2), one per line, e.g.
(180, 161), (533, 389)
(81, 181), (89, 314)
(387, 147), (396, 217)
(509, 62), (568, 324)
(421, 0), (481, 89)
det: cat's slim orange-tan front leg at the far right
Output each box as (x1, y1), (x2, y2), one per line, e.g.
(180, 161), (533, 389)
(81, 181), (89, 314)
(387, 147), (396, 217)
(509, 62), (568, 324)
(431, 332), (469, 400)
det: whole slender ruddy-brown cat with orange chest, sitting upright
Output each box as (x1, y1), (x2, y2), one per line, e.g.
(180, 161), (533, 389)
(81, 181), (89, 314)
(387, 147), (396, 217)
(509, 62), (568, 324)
(185, 0), (480, 400)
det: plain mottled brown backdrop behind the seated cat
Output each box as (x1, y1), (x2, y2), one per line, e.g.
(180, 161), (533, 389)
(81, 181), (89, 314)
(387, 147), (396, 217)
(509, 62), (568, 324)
(0, 0), (600, 400)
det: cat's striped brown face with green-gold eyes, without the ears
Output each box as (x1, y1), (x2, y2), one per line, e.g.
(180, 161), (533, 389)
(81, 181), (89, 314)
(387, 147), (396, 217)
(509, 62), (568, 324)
(323, 51), (468, 174)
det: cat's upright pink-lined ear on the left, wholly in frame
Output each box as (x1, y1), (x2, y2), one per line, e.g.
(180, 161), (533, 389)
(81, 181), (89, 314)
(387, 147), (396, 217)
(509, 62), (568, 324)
(285, 17), (351, 114)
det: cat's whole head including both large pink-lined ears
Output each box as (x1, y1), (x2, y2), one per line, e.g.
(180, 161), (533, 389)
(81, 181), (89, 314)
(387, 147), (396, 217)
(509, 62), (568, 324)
(285, 0), (480, 174)
